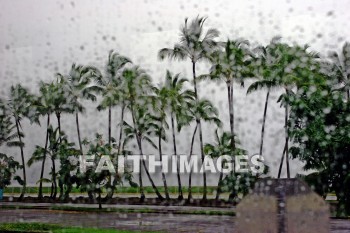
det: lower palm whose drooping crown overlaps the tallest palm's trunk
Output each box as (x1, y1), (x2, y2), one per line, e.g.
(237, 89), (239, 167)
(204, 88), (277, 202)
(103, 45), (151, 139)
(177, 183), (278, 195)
(186, 99), (221, 201)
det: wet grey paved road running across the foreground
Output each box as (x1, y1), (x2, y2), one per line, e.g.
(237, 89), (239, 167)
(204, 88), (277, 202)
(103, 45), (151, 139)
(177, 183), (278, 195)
(0, 206), (350, 233)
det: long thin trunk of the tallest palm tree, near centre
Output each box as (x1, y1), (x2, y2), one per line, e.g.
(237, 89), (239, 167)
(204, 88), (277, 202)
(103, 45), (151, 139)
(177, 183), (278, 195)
(192, 61), (207, 200)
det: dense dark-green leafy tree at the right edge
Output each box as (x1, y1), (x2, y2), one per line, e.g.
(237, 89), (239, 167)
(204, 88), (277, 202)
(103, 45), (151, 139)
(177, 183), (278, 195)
(284, 53), (350, 216)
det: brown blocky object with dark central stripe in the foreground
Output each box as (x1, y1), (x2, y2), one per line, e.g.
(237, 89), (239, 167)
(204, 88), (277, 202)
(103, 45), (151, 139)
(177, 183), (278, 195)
(237, 179), (330, 233)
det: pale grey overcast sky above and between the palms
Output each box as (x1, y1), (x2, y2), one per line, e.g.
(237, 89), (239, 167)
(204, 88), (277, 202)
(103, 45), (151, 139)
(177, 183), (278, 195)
(0, 0), (350, 184)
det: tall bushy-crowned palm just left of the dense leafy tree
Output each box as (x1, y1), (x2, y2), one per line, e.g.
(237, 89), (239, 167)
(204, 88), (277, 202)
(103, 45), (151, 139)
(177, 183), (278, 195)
(248, 38), (318, 178)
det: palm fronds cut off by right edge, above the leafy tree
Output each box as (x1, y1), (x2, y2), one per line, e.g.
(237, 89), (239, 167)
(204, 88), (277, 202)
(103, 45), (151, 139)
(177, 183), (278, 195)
(329, 42), (350, 100)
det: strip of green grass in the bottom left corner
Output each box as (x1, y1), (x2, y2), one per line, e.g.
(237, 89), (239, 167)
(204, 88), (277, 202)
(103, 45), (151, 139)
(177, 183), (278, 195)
(0, 223), (157, 233)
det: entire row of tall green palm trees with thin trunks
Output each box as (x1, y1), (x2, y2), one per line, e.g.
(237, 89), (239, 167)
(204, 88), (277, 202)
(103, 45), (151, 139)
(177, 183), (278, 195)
(1, 17), (350, 200)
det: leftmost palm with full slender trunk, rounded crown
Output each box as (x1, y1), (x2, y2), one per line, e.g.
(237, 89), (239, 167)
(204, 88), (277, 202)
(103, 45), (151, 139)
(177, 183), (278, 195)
(6, 84), (36, 200)
